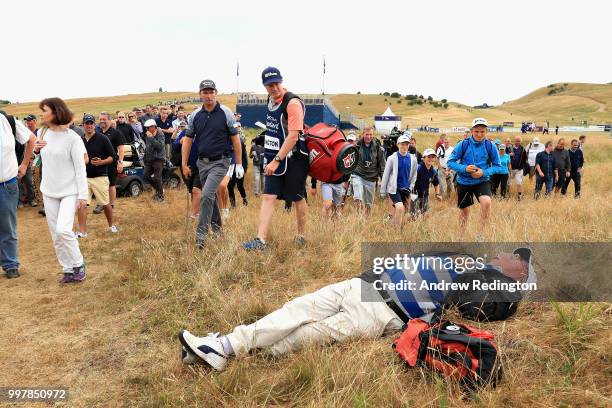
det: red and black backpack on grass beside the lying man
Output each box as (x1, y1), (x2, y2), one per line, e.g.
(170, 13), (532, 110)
(393, 319), (503, 390)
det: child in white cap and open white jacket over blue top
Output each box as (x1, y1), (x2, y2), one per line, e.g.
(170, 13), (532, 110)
(380, 133), (417, 229)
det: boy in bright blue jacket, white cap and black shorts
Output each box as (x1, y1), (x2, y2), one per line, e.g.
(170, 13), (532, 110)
(447, 118), (501, 241)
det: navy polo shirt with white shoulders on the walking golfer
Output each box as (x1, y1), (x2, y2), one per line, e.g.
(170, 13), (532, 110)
(185, 102), (238, 158)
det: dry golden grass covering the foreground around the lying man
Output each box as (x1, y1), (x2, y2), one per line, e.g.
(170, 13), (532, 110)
(0, 126), (612, 408)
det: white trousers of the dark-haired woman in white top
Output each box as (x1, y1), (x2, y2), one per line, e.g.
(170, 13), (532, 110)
(43, 195), (83, 272)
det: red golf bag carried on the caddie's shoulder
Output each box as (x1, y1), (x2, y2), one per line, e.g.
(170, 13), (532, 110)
(304, 123), (359, 183)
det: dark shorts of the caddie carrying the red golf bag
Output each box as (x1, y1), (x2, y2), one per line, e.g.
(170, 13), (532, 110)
(264, 153), (308, 201)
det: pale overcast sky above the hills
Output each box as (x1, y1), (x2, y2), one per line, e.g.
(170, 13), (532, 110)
(0, 0), (612, 104)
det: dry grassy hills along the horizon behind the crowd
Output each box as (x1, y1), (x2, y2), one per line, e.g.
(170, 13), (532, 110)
(5, 83), (612, 127)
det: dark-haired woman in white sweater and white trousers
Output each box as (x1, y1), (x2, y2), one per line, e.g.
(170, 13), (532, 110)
(35, 98), (87, 283)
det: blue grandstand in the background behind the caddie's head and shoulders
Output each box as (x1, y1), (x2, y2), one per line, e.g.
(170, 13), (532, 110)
(236, 93), (363, 129)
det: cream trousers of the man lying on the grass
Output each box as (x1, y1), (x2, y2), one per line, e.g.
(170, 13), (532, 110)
(227, 278), (403, 356)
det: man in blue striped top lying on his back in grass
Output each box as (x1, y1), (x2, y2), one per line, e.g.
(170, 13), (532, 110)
(178, 248), (535, 371)
